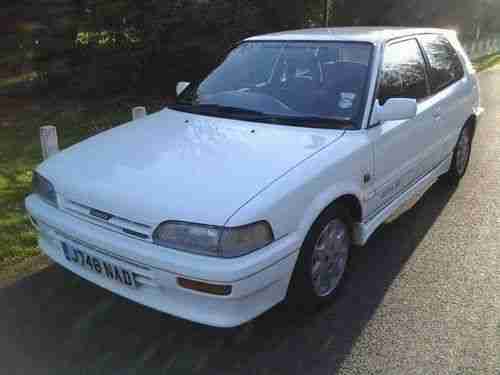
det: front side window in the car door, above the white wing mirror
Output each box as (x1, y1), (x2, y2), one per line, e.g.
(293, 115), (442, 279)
(378, 39), (428, 104)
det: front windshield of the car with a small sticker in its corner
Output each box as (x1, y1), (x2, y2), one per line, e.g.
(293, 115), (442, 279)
(173, 41), (372, 129)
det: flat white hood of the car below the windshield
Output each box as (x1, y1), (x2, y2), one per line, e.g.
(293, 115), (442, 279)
(38, 109), (344, 226)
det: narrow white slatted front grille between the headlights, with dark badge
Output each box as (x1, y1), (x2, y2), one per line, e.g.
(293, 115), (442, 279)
(62, 199), (153, 242)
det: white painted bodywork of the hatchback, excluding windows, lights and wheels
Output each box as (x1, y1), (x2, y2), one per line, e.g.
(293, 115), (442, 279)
(26, 28), (480, 327)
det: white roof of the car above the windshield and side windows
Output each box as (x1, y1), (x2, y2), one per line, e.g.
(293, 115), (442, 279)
(246, 27), (453, 43)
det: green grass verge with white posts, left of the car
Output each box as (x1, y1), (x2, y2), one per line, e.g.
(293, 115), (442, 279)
(0, 97), (143, 279)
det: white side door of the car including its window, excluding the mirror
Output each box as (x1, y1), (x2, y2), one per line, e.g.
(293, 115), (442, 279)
(368, 38), (439, 219)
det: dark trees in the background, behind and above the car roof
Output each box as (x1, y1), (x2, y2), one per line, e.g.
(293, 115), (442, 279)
(20, 0), (500, 96)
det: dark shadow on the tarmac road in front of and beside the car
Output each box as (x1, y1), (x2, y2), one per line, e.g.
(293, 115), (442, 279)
(0, 183), (453, 374)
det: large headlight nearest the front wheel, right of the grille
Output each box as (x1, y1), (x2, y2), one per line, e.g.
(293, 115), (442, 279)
(153, 221), (274, 258)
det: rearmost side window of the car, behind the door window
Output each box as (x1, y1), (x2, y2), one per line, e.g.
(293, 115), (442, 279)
(420, 35), (464, 92)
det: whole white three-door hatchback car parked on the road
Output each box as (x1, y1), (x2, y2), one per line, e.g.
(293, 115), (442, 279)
(26, 28), (481, 327)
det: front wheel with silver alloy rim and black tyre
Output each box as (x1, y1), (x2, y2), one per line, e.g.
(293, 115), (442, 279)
(288, 205), (352, 312)
